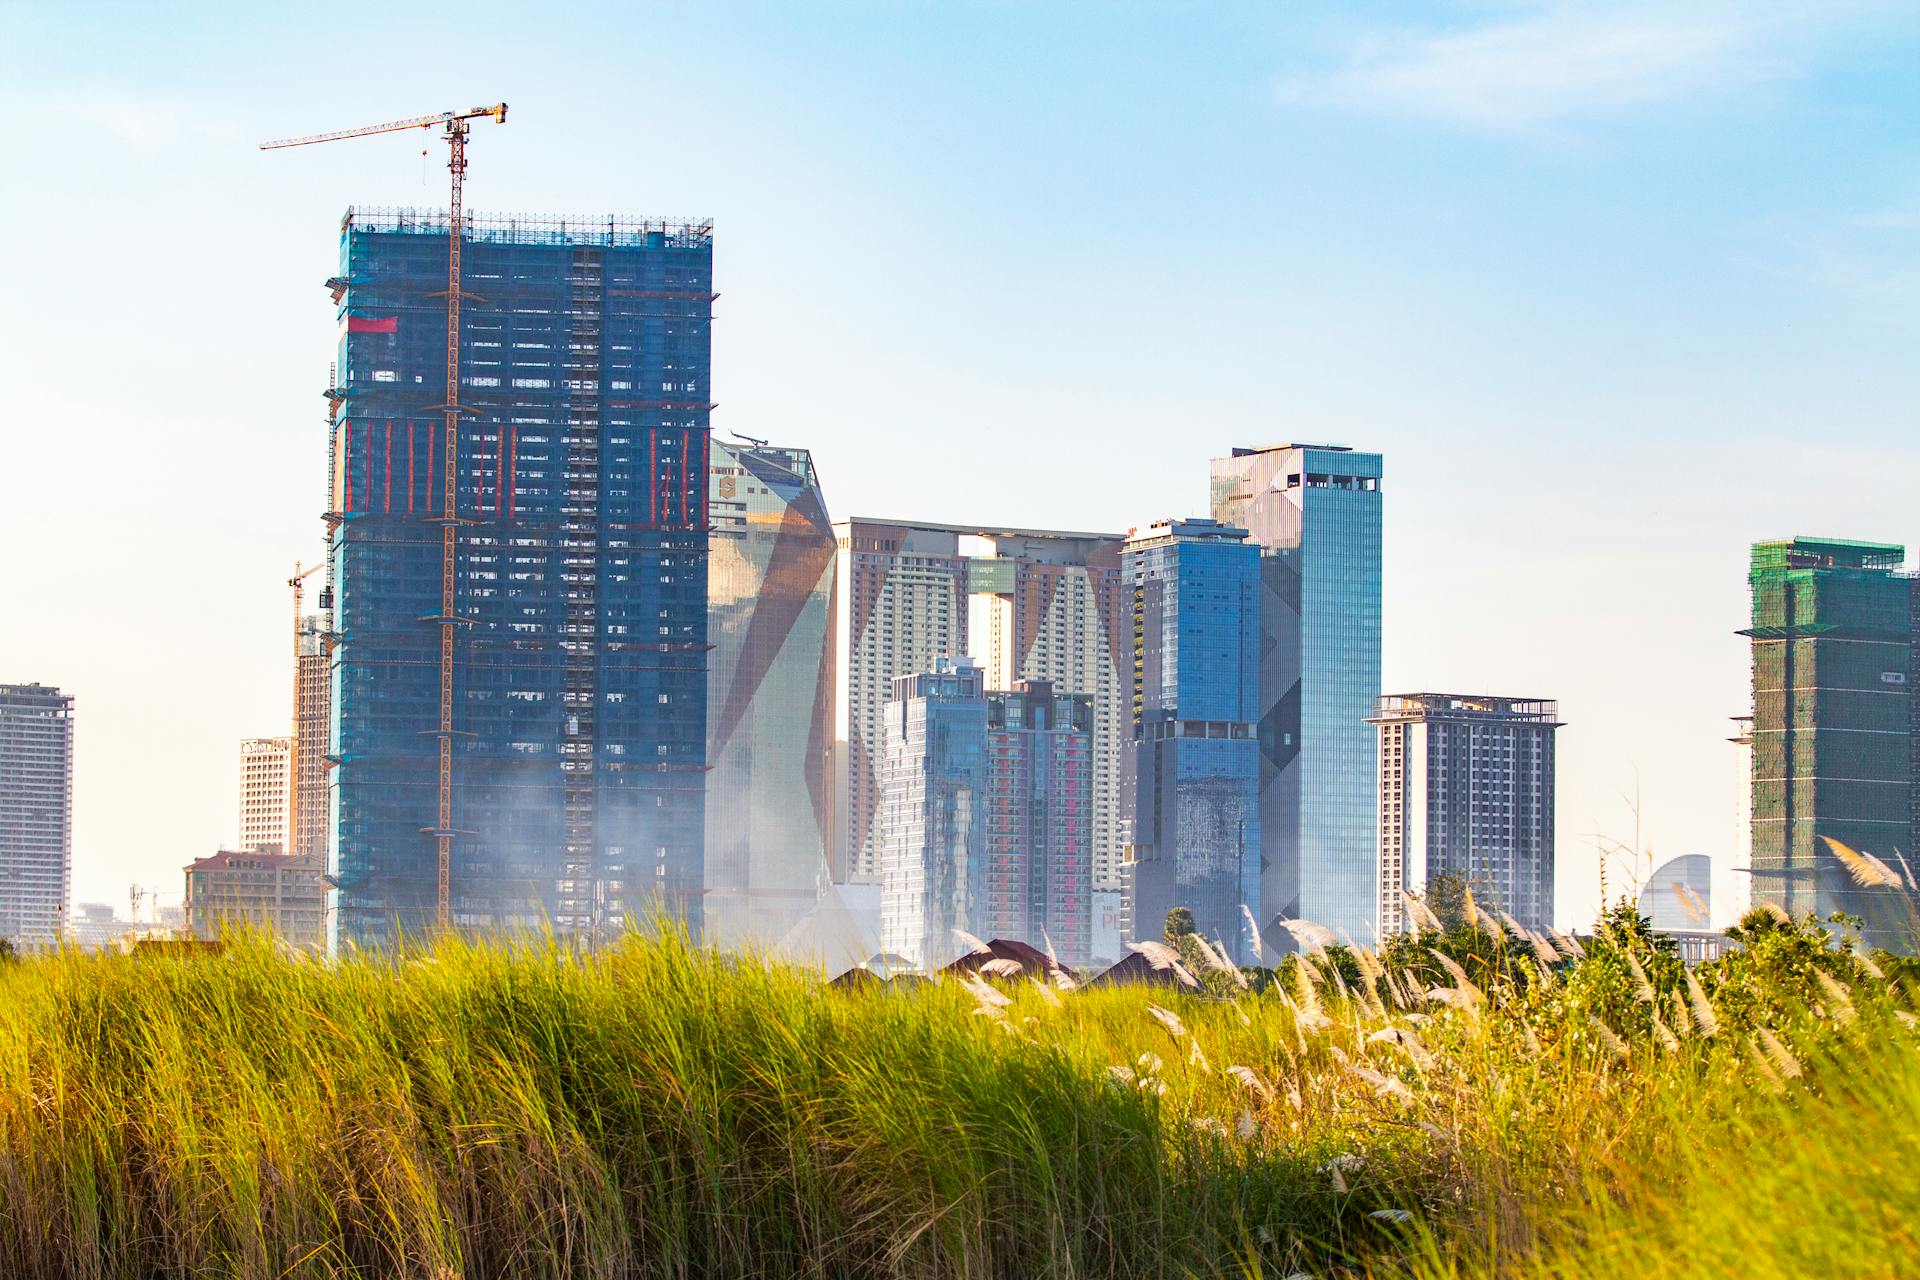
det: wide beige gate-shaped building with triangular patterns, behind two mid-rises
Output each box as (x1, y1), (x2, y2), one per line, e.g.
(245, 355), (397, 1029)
(833, 518), (1127, 887)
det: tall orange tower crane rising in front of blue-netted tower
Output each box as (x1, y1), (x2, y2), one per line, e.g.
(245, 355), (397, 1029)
(259, 102), (507, 931)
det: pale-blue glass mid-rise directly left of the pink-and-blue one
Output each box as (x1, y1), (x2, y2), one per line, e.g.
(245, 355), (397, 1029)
(877, 658), (989, 969)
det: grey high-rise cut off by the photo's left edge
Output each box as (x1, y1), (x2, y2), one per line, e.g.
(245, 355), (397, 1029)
(0, 685), (73, 946)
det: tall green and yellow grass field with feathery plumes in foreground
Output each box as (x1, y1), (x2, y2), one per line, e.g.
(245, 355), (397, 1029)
(0, 910), (1920, 1280)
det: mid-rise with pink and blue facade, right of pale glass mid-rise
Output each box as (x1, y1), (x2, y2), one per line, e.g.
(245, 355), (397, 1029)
(990, 679), (1096, 967)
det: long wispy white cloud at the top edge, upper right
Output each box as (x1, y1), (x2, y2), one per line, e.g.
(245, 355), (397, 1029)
(1281, 0), (1855, 130)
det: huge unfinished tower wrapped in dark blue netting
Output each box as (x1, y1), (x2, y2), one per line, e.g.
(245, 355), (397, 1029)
(328, 209), (714, 944)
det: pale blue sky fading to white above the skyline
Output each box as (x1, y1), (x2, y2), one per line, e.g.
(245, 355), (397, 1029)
(0, 0), (1920, 925)
